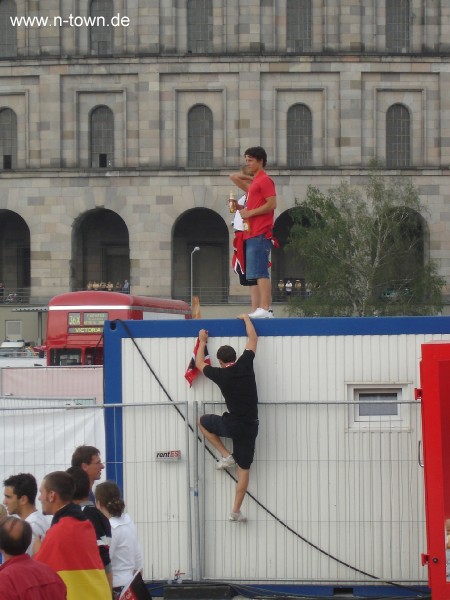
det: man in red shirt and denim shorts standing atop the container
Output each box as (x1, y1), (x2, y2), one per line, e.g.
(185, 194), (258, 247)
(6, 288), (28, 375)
(230, 146), (277, 319)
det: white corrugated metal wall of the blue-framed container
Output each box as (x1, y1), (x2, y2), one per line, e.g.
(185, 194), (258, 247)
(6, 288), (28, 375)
(107, 325), (449, 584)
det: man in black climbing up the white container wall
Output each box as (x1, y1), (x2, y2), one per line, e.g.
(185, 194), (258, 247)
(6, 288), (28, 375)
(195, 315), (258, 522)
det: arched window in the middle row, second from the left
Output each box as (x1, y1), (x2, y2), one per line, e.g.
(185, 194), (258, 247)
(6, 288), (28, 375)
(89, 106), (114, 169)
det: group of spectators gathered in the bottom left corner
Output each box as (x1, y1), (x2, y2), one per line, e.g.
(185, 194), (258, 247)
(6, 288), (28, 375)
(0, 445), (146, 600)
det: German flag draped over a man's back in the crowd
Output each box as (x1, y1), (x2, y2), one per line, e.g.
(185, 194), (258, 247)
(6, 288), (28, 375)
(34, 504), (111, 600)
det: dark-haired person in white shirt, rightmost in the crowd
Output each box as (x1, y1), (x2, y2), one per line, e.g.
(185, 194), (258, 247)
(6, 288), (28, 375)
(95, 481), (144, 592)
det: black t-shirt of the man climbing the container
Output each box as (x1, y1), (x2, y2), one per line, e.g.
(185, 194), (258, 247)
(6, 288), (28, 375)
(203, 350), (258, 421)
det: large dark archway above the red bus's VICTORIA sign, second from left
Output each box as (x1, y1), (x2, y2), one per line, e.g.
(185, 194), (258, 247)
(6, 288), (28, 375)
(70, 208), (130, 291)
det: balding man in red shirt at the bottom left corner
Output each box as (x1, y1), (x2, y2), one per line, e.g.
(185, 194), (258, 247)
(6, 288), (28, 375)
(0, 517), (67, 600)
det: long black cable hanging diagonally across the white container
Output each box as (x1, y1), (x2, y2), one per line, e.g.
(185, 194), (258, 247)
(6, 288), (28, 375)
(112, 319), (430, 598)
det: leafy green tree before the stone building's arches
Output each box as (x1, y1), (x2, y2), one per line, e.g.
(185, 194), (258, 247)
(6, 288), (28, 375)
(287, 168), (445, 316)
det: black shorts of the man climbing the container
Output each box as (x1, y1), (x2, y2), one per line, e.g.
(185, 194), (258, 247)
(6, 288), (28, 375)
(200, 413), (259, 469)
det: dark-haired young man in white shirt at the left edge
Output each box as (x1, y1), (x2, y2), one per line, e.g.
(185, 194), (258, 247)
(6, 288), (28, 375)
(3, 473), (50, 556)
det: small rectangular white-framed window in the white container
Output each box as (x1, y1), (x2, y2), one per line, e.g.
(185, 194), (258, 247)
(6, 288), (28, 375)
(348, 384), (413, 430)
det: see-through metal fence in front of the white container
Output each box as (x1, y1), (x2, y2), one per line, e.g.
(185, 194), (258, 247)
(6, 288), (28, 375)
(0, 398), (426, 586)
